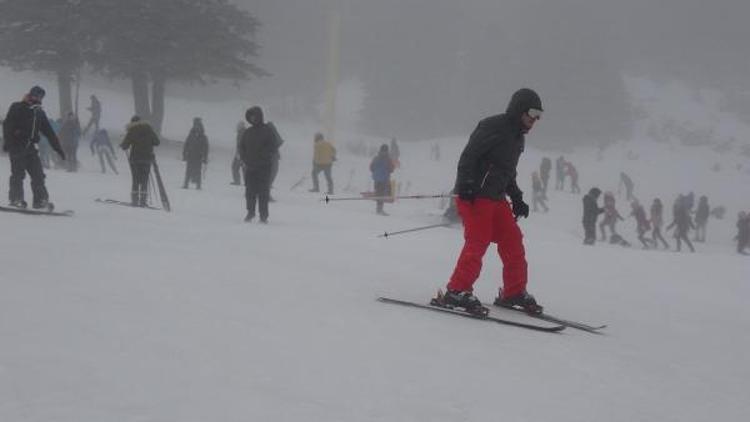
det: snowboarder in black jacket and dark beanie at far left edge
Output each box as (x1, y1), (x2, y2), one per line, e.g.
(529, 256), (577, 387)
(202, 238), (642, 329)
(3, 86), (65, 208)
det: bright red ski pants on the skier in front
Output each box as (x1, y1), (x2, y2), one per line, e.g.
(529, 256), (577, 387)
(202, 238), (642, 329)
(448, 198), (527, 297)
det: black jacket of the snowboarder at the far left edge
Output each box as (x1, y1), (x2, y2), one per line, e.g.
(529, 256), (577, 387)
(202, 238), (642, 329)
(3, 101), (62, 155)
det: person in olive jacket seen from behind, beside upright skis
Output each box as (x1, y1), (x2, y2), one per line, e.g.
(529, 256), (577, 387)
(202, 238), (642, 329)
(120, 116), (160, 207)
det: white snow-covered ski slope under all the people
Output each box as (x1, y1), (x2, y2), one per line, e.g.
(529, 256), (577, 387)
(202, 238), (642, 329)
(0, 115), (750, 422)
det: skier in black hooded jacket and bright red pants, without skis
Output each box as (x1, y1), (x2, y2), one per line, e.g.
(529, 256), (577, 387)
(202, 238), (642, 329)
(433, 88), (542, 315)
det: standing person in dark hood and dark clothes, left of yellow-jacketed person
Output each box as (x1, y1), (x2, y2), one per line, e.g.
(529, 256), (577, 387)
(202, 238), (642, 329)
(239, 106), (279, 223)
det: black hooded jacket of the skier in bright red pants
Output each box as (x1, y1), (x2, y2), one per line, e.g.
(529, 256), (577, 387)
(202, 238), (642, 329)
(455, 89), (542, 200)
